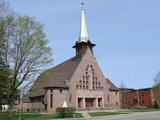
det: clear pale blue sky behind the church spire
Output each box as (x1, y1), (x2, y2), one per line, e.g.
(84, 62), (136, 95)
(6, 0), (160, 88)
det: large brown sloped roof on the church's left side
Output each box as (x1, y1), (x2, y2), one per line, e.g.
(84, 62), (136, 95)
(30, 57), (81, 97)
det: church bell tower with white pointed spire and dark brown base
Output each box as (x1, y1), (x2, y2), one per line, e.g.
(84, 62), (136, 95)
(73, 3), (96, 57)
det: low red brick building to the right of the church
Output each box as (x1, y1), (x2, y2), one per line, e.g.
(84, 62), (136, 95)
(120, 88), (155, 108)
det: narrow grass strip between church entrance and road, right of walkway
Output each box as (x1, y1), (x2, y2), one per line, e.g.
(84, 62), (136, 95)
(89, 112), (129, 117)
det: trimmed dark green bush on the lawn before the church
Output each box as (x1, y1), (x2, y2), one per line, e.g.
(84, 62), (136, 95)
(56, 107), (75, 118)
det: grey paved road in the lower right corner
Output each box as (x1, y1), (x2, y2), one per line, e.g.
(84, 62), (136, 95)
(92, 112), (160, 120)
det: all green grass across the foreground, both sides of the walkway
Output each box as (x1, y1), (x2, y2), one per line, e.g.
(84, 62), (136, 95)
(0, 108), (160, 120)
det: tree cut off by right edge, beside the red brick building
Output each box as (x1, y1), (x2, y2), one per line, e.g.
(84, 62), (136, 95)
(153, 72), (160, 107)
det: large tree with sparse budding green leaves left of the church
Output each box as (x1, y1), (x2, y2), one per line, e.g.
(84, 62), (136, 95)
(9, 16), (52, 107)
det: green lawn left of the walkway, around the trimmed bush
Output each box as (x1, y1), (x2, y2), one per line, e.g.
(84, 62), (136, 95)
(0, 112), (82, 120)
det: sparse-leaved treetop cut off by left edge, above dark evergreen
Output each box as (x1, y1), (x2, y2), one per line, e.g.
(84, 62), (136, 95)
(0, 0), (15, 65)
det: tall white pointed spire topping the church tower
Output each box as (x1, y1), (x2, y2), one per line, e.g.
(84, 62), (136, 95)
(79, 2), (89, 42)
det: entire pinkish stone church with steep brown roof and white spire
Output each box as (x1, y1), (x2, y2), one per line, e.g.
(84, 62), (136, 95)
(19, 6), (120, 112)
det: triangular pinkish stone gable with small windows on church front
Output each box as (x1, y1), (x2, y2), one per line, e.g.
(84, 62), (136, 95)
(71, 49), (109, 90)
